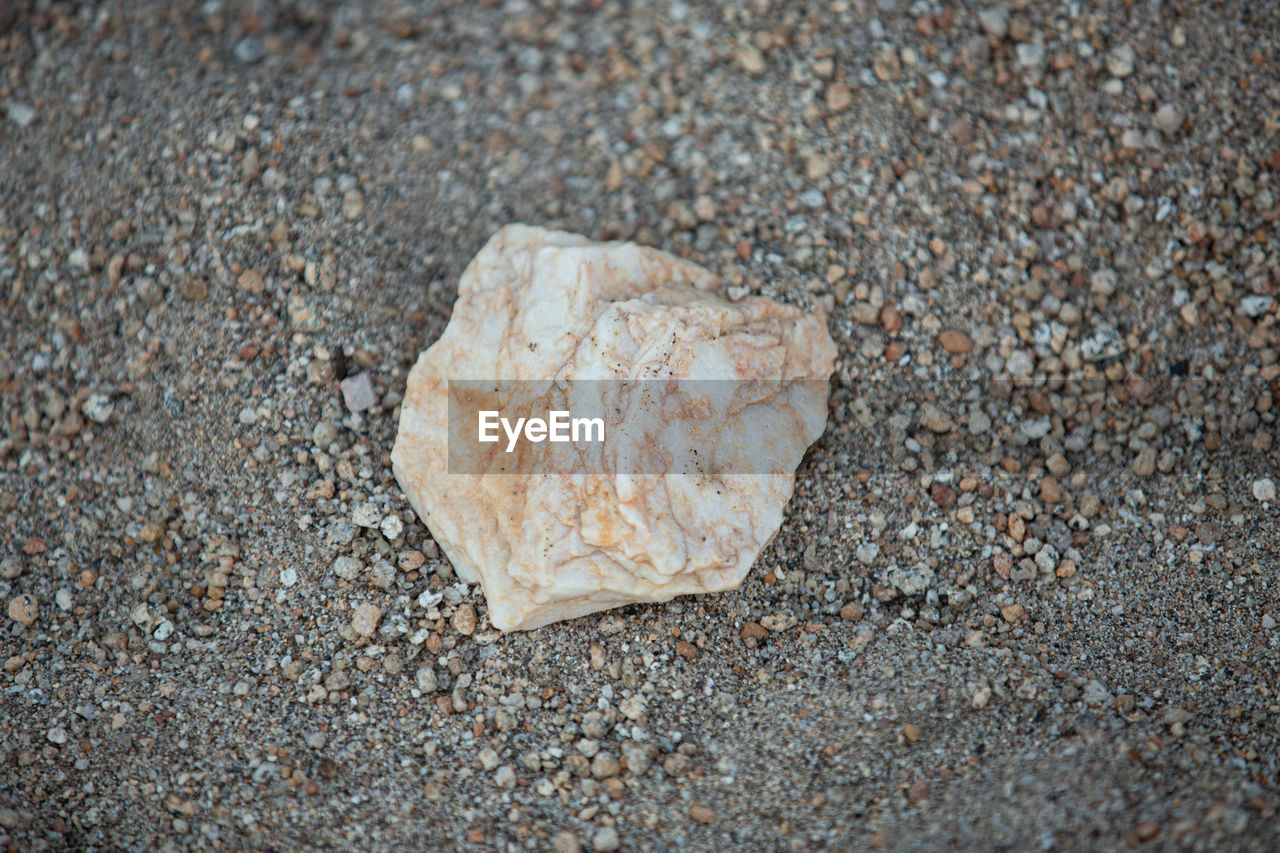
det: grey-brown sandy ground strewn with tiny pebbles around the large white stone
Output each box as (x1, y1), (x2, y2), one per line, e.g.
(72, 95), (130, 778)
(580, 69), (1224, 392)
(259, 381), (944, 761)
(0, 0), (1280, 850)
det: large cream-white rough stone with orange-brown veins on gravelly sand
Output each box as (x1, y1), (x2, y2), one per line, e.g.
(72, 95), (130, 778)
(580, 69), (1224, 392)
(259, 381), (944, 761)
(392, 225), (836, 631)
